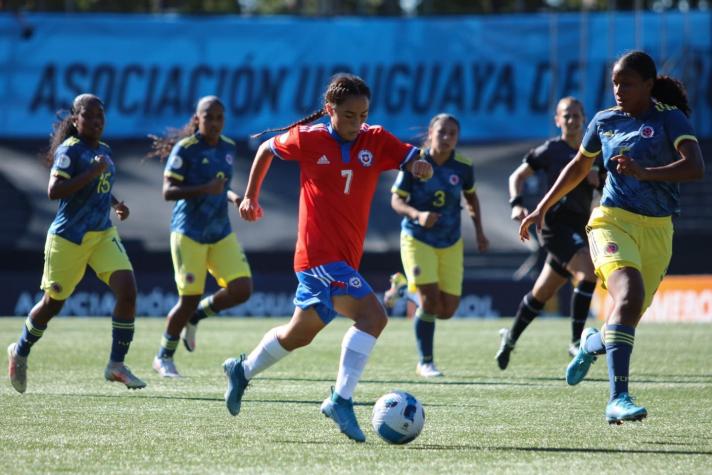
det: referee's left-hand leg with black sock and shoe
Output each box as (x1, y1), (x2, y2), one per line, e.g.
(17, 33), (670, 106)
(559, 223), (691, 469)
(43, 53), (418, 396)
(495, 255), (568, 370)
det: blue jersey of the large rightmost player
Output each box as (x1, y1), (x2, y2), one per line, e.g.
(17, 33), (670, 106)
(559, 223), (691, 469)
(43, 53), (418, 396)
(581, 102), (697, 216)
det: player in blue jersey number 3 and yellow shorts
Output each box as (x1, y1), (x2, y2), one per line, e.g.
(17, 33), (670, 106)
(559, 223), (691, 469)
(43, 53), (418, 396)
(391, 114), (489, 378)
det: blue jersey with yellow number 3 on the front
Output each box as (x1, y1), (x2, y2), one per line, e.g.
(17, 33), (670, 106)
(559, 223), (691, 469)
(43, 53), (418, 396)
(391, 151), (475, 248)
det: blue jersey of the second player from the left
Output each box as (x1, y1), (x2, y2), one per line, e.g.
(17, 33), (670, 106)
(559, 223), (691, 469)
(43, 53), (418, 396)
(163, 133), (236, 244)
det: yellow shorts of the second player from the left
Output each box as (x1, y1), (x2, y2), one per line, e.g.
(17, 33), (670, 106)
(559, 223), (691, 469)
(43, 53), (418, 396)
(171, 232), (252, 295)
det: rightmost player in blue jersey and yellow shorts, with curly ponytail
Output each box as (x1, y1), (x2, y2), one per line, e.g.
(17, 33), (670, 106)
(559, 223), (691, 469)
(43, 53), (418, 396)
(519, 51), (704, 424)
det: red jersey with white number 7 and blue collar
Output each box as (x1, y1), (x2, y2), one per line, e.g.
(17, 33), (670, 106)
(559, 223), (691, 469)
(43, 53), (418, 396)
(269, 124), (418, 272)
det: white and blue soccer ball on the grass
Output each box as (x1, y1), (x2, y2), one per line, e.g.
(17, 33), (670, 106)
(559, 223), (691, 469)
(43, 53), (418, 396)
(371, 391), (425, 444)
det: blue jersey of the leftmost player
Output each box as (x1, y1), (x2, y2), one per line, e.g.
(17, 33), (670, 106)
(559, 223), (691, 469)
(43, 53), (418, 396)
(49, 137), (116, 244)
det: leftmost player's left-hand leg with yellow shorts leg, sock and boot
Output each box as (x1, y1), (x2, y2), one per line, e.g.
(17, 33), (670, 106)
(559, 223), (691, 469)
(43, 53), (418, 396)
(7, 234), (88, 393)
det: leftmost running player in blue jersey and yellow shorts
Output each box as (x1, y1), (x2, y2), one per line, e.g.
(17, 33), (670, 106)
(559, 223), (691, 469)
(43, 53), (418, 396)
(7, 94), (146, 393)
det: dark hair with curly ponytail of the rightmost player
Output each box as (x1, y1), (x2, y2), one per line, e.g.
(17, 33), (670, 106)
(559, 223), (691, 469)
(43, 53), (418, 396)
(618, 51), (692, 117)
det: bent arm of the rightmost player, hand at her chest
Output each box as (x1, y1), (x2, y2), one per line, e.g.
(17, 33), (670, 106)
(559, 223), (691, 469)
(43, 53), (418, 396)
(612, 139), (705, 182)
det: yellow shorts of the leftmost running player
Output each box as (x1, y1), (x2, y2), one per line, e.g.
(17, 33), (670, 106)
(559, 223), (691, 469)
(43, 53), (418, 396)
(41, 226), (133, 300)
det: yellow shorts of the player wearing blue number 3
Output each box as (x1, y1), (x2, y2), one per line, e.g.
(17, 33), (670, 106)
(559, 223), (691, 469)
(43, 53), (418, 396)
(401, 233), (464, 297)
